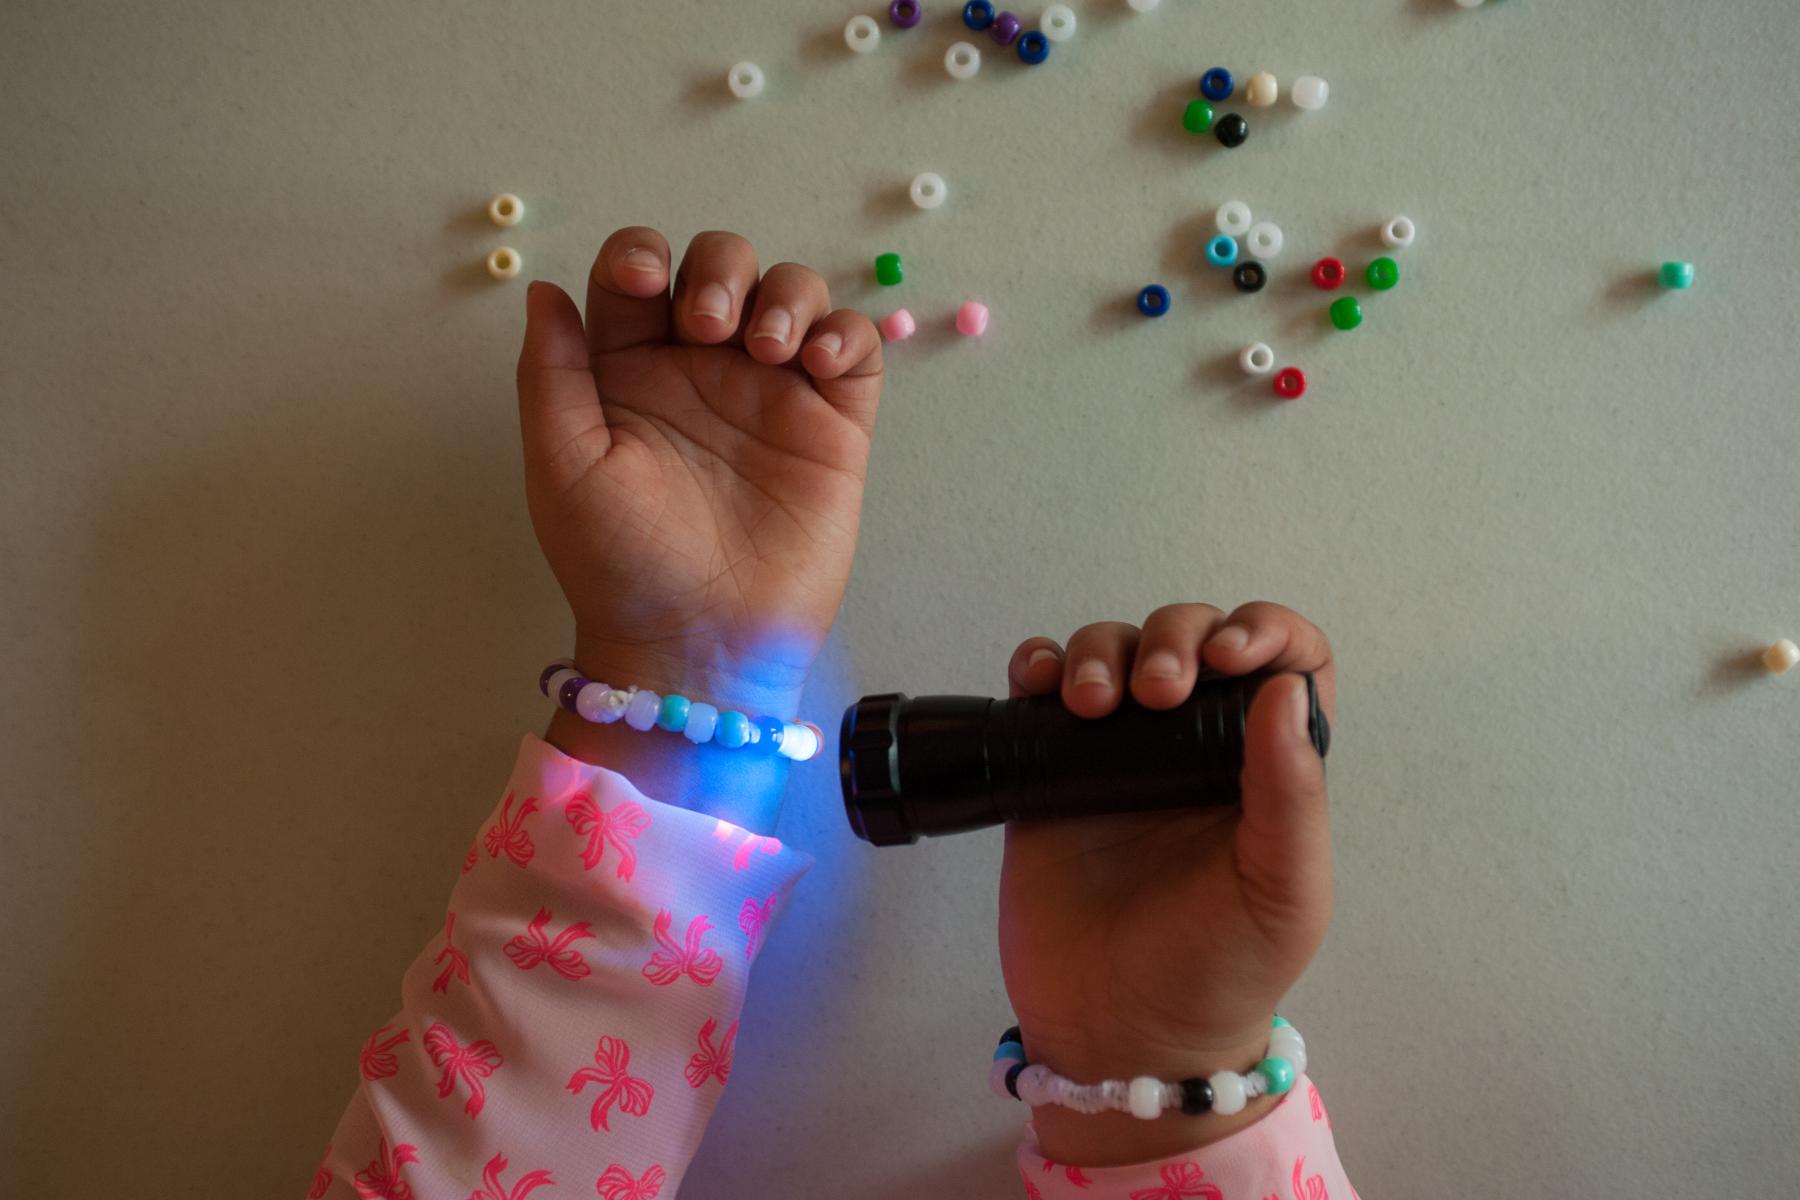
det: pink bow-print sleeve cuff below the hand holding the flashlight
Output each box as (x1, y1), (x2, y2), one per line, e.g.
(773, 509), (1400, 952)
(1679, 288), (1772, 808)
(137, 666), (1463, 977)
(1019, 1076), (1357, 1200)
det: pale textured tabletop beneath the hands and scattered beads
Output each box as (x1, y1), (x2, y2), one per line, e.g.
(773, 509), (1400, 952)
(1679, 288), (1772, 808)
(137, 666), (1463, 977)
(0, 0), (1800, 1200)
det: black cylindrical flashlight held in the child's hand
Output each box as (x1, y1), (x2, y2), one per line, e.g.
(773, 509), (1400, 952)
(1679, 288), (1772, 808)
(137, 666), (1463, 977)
(837, 671), (1332, 846)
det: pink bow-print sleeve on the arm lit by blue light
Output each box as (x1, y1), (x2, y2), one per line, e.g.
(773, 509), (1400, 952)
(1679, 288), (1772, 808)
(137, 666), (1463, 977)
(306, 734), (812, 1200)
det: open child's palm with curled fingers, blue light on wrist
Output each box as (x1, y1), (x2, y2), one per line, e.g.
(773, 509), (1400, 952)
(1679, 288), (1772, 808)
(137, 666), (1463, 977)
(518, 228), (882, 720)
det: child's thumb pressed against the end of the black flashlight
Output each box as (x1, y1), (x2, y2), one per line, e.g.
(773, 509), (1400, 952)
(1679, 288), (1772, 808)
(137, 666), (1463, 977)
(1237, 675), (1332, 957)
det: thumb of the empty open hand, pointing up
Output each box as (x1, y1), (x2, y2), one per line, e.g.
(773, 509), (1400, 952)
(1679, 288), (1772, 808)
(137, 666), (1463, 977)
(518, 282), (612, 491)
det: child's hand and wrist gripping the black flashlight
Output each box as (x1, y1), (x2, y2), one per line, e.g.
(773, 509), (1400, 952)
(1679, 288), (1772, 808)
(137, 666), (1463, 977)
(1001, 604), (1336, 1166)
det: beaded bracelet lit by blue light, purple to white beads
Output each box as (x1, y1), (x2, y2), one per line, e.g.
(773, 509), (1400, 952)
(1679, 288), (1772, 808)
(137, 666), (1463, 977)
(538, 658), (824, 763)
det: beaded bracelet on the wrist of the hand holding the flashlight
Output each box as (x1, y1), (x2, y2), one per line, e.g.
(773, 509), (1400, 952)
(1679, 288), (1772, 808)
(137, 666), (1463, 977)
(988, 1016), (1307, 1121)
